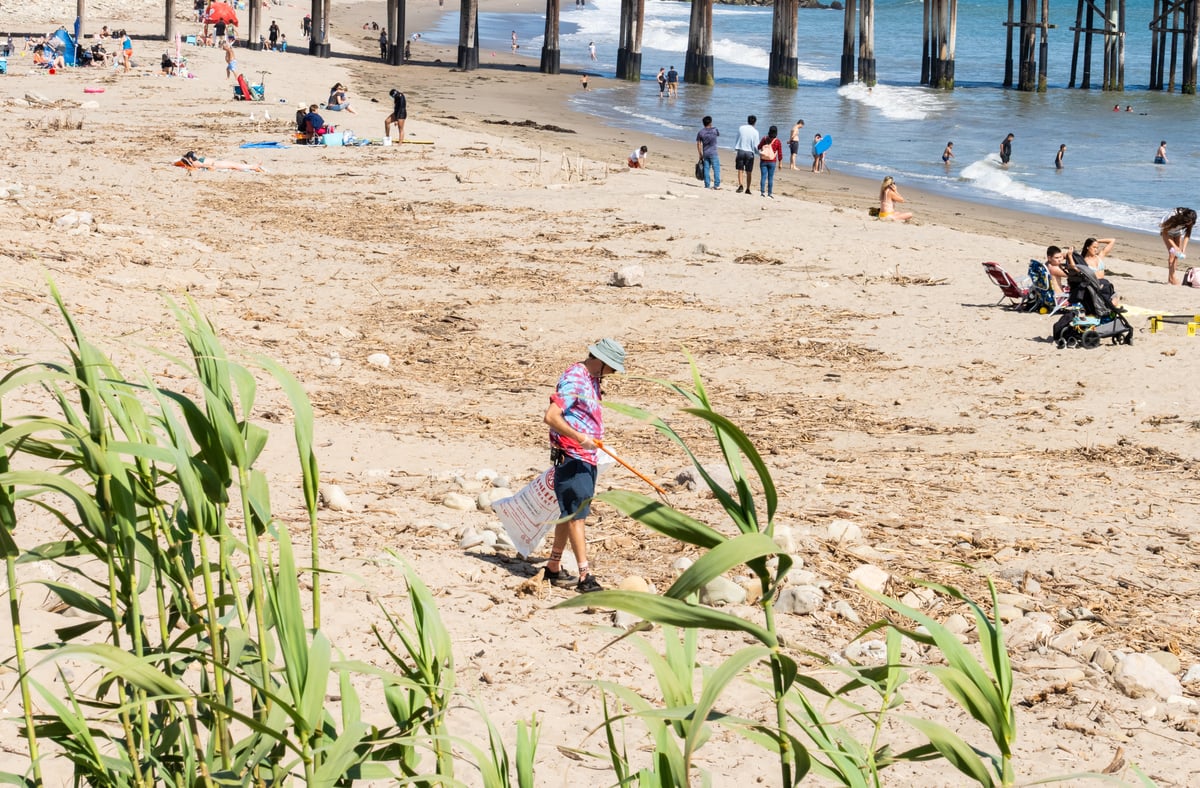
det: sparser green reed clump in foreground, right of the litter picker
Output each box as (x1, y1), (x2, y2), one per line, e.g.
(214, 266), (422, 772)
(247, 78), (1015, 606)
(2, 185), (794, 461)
(558, 362), (1152, 788)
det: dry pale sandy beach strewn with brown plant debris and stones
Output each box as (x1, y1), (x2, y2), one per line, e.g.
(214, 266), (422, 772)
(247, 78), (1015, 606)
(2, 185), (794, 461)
(0, 0), (1200, 786)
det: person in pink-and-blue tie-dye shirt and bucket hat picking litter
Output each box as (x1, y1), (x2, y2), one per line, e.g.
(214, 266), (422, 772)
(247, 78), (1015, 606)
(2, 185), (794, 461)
(542, 338), (625, 594)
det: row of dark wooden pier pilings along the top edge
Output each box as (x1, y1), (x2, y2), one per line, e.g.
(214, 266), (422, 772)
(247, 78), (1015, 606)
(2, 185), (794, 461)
(117, 0), (1200, 95)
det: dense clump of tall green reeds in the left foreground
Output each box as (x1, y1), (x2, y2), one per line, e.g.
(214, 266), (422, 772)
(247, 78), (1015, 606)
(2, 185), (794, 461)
(0, 285), (538, 788)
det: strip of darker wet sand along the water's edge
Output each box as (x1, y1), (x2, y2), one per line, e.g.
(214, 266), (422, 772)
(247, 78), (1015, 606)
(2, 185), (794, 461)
(334, 0), (1186, 282)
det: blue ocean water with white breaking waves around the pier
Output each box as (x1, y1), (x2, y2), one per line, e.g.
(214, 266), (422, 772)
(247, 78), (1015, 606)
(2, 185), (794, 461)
(425, 0), (1200, 233)
